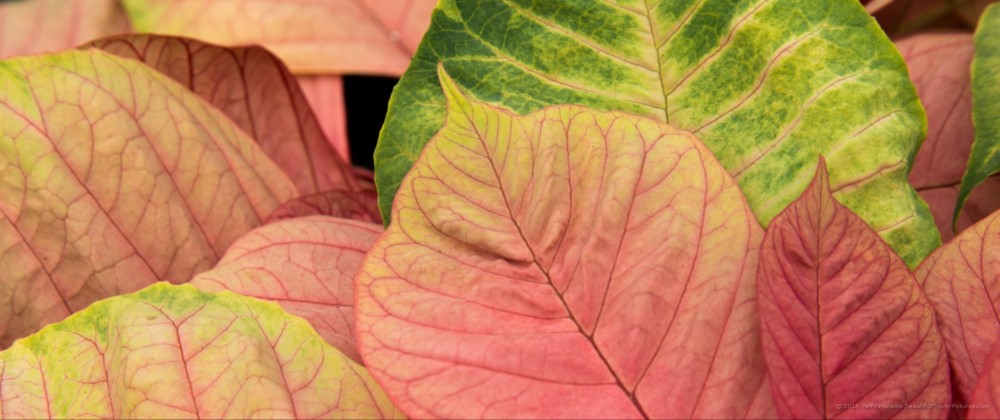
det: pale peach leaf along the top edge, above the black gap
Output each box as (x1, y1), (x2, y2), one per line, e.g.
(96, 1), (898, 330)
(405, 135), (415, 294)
(122, 0), (435, 76)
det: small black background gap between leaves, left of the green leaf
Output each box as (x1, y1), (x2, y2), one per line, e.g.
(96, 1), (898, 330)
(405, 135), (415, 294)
(344, 76), (399, 169)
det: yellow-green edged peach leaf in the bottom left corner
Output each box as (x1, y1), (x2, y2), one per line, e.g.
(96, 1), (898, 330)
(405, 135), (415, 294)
(0, 283), (400, 419)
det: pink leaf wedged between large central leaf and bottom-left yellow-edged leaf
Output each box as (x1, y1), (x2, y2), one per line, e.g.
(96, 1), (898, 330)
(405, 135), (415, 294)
(191, 216), (382, 362)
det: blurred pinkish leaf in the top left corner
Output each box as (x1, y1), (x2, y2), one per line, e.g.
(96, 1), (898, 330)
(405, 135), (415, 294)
(0, 0), (131, 59)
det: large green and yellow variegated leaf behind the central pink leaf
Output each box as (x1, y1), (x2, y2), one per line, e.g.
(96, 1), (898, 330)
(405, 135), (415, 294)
(375, 0), (940, 265)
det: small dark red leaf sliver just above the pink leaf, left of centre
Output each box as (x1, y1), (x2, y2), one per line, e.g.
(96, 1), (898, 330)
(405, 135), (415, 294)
(264, 190), (382, 224)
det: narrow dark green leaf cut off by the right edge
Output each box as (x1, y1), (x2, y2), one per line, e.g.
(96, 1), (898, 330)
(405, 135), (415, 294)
(954, 5), (1000, 226)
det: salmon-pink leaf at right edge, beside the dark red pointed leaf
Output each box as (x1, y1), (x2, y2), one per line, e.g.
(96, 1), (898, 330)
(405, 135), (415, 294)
(916, 212), (1000, 401)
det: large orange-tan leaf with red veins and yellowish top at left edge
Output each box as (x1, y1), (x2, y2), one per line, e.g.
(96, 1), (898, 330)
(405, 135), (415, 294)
(0, 50), (298, 347)
